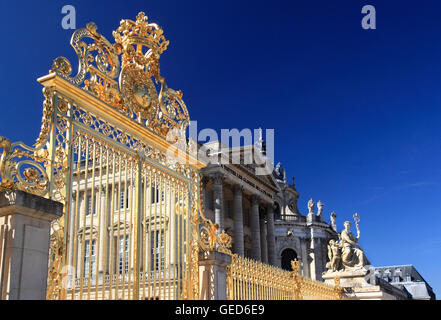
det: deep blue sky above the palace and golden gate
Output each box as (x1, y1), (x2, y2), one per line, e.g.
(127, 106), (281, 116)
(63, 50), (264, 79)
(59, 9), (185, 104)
(0, 0), (441, 295)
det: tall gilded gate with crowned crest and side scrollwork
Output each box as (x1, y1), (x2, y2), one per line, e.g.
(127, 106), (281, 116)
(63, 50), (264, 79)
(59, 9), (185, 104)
(0, 13), (206, 299)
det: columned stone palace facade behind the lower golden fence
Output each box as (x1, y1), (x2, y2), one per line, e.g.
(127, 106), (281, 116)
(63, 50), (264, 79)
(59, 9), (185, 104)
(198, 141), (338, 280)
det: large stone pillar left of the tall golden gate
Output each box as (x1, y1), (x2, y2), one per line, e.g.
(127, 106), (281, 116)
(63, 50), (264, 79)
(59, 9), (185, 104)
(0, 190), (63, 300)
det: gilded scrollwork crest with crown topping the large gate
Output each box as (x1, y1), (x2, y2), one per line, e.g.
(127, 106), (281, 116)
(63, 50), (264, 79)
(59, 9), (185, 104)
(50, 12), (189, 138)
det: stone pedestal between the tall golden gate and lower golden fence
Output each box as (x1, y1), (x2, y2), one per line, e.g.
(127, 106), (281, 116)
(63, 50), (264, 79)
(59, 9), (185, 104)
(199, 251), (231, 300)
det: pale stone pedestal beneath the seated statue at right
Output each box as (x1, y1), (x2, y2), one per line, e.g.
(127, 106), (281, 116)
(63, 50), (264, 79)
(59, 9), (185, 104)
(322, 267), (408, 300)
